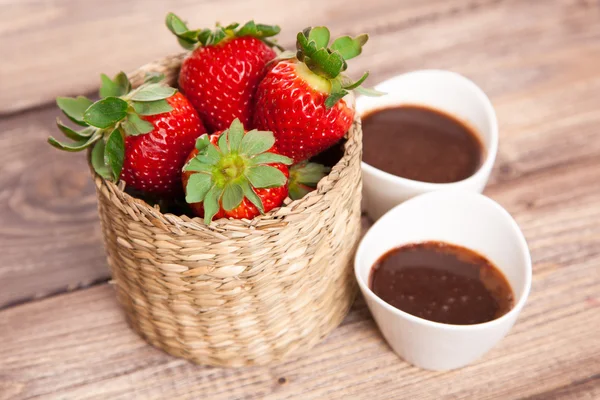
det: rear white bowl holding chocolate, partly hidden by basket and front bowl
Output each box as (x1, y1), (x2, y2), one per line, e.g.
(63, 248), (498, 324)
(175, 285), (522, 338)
(356, 70), (498, 221)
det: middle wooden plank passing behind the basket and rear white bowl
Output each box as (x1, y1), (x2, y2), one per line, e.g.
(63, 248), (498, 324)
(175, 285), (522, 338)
(0, 1), (600, 307)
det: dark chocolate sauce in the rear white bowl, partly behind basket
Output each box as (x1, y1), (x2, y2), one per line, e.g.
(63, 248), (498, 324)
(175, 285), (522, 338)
(362, 105), (485, 183)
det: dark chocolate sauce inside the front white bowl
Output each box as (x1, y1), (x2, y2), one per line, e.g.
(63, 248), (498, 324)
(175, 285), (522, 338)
(369, 242), (514, 325)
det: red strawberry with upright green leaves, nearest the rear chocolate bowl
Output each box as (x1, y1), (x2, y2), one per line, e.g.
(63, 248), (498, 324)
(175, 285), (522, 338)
(254, 27), (377, 162)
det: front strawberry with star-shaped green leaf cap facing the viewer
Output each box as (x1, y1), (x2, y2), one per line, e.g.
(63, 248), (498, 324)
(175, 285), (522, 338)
(183, 119), (292, 225)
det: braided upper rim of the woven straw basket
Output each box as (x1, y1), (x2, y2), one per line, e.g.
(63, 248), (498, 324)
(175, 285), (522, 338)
(87, 53), (361, 230)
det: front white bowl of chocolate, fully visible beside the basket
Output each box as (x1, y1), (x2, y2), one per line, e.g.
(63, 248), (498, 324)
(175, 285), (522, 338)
(354, 190), (531, 370)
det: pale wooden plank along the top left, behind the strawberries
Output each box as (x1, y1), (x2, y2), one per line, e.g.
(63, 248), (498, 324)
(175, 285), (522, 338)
(0, 0), (489, 113)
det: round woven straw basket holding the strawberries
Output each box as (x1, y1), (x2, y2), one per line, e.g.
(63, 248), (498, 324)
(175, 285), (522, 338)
(94, 55), (362, 366)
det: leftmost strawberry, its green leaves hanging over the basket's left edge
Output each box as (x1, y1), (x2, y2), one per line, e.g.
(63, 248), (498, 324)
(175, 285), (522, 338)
(48, 72), (206, 196)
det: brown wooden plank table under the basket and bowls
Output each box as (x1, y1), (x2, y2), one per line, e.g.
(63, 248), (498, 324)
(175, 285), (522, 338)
(0, 0), (600, 399)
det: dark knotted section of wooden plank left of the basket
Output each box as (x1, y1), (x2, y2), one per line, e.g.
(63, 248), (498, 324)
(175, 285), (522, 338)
(0, 107), (108, 307)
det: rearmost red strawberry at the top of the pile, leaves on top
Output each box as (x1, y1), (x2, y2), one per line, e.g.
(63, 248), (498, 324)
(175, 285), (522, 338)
(166, 13), (280, 132)
